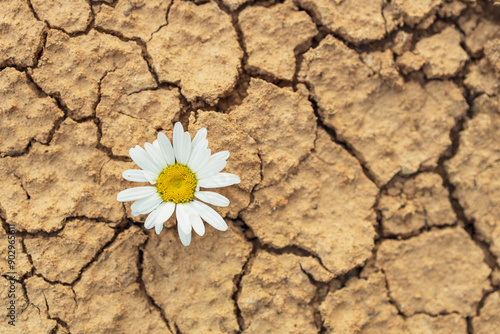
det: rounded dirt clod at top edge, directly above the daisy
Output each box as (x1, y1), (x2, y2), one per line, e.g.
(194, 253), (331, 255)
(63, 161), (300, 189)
(147, 1), (243, 105)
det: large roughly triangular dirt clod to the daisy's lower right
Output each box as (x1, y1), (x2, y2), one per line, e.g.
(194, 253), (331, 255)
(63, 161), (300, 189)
(241, 130), (377, 275)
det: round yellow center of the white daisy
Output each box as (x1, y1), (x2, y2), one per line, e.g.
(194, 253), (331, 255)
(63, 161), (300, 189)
(156, 163), (198, 204)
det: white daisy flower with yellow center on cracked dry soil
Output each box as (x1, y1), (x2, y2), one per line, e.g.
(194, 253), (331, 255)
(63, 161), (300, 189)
(117, 122), (240, 246)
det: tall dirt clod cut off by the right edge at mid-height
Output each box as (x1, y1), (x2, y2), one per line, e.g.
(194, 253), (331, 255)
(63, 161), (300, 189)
(445, 95), (500, 248)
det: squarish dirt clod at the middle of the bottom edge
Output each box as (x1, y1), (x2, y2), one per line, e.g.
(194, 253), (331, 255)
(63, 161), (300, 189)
(238, 252), (316, 334)
